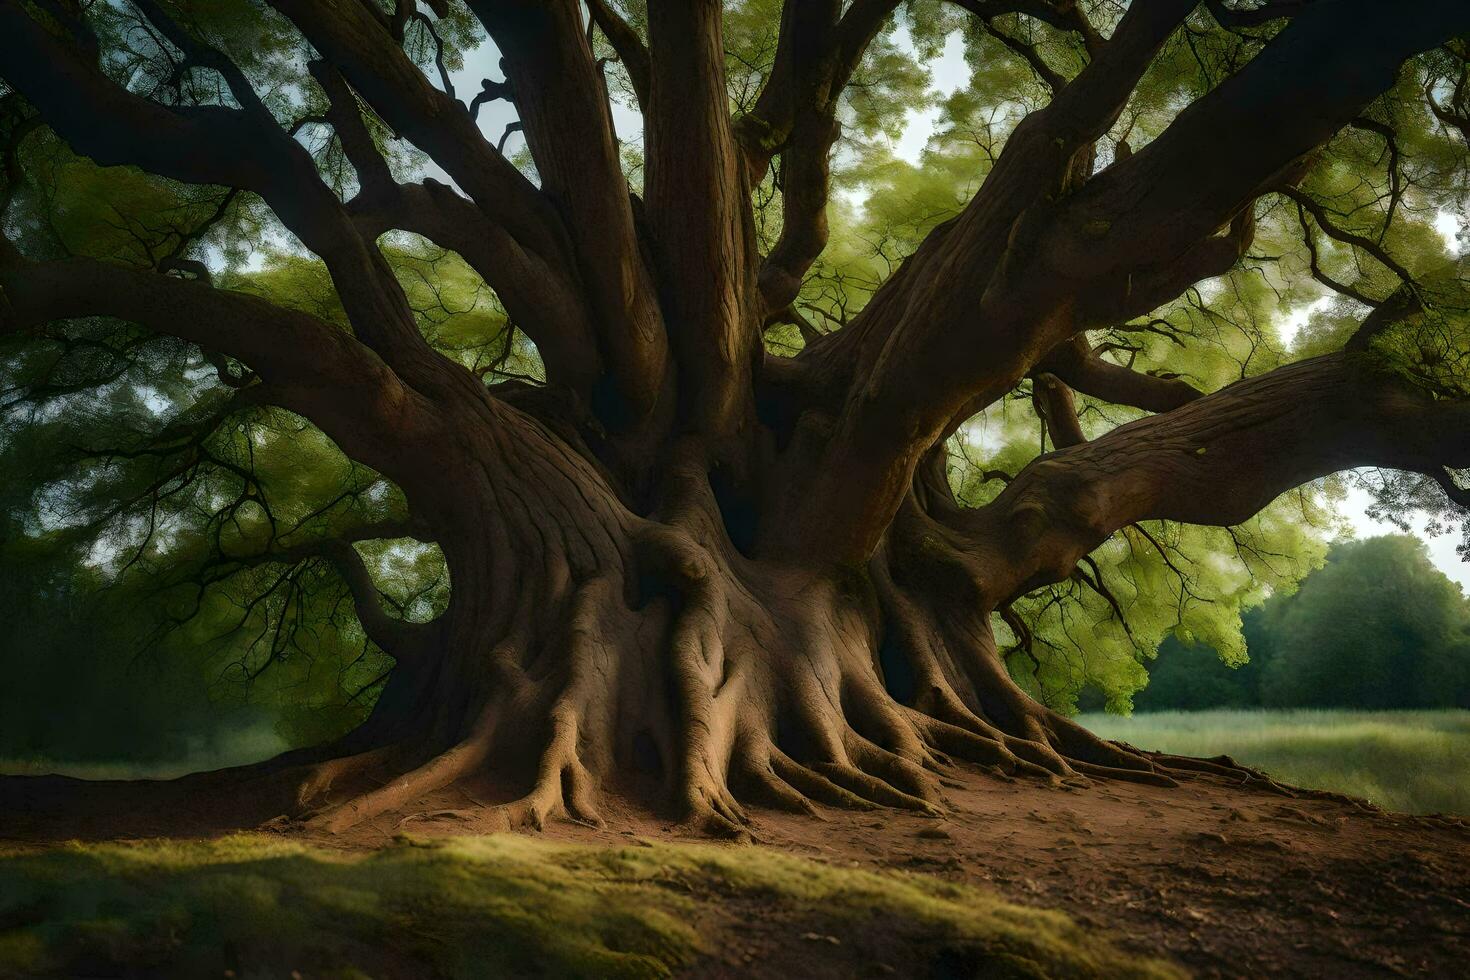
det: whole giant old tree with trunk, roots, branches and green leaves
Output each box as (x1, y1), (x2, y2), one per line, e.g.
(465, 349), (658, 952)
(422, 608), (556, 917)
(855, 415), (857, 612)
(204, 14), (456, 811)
(0, 0), (1470, 832)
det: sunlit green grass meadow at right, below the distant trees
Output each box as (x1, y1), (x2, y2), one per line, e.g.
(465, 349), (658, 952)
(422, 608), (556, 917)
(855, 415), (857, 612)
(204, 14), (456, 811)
(1078, 711), (1470, 817)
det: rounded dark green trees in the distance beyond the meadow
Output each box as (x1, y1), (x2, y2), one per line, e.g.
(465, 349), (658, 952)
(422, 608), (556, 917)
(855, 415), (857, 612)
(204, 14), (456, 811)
(1134, 535), (1470, 711)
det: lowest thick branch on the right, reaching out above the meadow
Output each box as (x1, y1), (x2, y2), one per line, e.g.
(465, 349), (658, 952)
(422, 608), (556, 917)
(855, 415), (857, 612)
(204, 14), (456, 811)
(950, 354), (1470, 602)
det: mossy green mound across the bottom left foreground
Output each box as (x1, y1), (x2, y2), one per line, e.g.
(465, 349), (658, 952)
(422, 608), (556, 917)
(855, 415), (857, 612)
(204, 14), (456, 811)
(0, 835), (1180, 979)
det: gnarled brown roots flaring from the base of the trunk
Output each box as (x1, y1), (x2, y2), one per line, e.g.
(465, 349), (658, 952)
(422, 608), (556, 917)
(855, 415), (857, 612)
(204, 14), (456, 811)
(246, 525), (1186, 837)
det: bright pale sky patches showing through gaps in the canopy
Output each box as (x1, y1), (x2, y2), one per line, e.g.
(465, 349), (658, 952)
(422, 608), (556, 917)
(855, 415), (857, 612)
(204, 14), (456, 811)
(454, 24), (1470, 592)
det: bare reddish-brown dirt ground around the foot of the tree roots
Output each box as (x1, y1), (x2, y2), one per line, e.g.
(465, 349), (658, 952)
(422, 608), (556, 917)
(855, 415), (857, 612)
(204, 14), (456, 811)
(0, 771), (1470, 977)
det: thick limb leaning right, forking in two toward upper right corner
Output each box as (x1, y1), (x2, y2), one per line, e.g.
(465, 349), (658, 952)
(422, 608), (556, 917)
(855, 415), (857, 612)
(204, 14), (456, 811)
(773, 0), (1470, 567)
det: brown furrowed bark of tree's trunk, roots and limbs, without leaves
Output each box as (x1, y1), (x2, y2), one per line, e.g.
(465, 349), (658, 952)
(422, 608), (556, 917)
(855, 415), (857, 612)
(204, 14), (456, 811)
(0, 0), (1470, 835)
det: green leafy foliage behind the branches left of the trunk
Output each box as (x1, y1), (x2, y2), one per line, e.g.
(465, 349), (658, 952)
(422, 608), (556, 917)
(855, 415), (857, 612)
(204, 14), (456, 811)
(0, 45), (523, 770)
